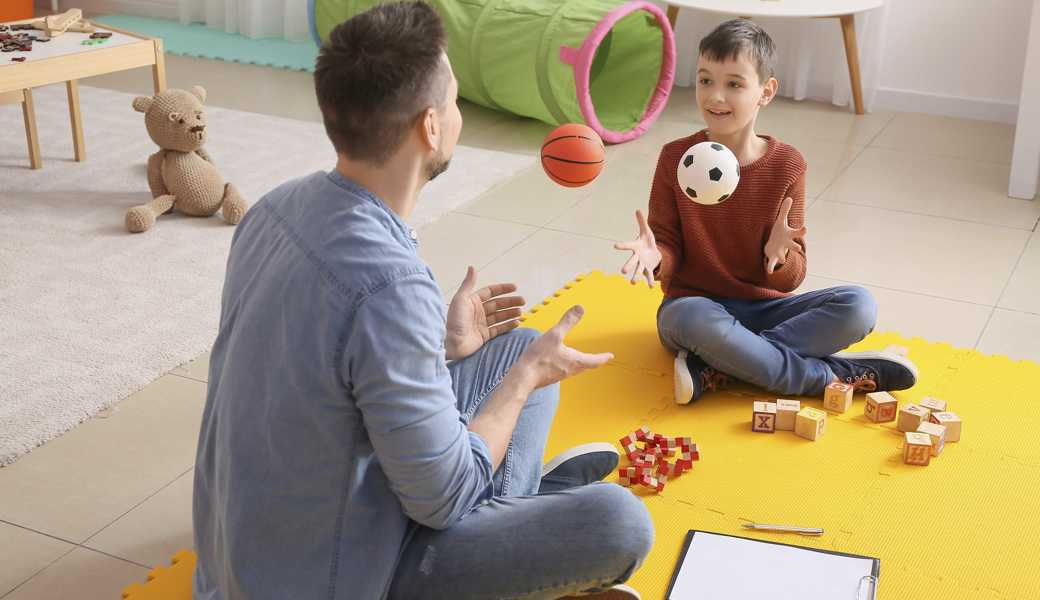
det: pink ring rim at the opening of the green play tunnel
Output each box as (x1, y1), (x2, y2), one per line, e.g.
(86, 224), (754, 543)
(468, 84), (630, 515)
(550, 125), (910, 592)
(560, 0), (675, 144)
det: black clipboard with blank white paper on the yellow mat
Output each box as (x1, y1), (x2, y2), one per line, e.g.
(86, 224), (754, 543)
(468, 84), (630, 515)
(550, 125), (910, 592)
(666, 529), (881, 600)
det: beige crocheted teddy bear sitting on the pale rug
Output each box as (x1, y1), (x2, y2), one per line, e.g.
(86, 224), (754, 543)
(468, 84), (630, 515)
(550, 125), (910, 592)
(126, 85), (248, 233)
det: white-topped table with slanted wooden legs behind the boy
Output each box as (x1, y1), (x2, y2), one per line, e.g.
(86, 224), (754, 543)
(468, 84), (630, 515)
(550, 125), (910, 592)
(665, 0), (884, 114)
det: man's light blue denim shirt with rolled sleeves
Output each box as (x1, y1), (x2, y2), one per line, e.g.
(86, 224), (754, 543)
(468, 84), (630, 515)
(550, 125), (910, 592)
(193, 171), (492, 600)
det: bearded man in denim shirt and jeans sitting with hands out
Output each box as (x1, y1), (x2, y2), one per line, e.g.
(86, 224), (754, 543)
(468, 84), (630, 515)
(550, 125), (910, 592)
(193, 2), (653, 600)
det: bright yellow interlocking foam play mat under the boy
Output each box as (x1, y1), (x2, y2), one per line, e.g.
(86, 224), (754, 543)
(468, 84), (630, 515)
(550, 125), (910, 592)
(124, 272), (1040, 600)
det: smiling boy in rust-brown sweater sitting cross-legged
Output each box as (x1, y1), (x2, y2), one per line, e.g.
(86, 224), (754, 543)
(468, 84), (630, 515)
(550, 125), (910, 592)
(615, 19), (917, 403)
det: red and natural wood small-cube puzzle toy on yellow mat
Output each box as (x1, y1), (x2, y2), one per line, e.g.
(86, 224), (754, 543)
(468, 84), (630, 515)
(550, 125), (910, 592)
(618, 425), (701, 492)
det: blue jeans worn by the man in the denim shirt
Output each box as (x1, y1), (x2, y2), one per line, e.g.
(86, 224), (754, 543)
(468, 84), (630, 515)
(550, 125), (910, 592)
(390, 329), (653, 600)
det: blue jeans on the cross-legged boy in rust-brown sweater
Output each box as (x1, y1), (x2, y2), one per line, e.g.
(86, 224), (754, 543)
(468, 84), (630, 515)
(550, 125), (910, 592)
(657, 286), (878, 396)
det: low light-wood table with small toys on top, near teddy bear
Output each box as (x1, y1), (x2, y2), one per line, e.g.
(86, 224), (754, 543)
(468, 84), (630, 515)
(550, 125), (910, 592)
(0, 21), (166, 168)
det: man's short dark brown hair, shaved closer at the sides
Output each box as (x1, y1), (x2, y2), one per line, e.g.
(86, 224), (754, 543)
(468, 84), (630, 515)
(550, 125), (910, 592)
(314, 1), (450, 164)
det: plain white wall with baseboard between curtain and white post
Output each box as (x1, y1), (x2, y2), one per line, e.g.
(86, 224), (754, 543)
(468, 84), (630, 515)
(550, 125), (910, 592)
(877, 0), (1040, 123)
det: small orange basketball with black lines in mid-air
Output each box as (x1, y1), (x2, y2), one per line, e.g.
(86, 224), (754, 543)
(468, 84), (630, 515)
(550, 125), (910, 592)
(542, 123), (604, 187)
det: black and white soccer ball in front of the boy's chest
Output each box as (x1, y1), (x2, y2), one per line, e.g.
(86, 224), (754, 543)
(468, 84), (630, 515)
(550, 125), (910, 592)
(676, 141), (740, 204)
